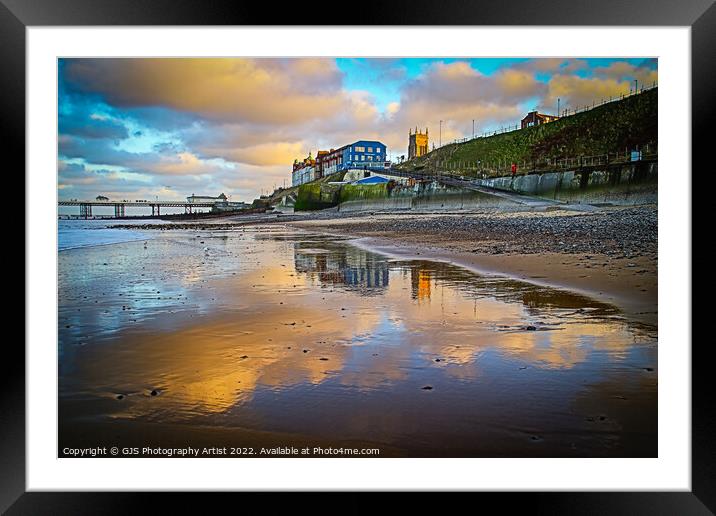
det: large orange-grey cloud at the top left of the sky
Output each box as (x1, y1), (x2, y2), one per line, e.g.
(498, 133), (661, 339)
(63, 58), (345, 124)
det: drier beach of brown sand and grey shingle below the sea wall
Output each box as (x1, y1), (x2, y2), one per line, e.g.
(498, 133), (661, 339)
(103, 205), (658, 326)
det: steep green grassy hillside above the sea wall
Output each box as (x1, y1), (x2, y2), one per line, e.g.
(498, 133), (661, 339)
(399, 88), (658, 175)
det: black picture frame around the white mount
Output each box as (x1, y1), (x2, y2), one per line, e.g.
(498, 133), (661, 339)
(0, 0), (716, 515)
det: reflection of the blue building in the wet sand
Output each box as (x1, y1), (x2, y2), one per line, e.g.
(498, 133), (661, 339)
(294, 243), (389, 294)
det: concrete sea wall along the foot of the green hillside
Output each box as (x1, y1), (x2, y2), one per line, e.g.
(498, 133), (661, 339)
(476, 162), (658, 205)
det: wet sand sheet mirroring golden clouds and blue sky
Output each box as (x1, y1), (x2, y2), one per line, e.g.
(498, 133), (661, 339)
(60, 231), (656, 456)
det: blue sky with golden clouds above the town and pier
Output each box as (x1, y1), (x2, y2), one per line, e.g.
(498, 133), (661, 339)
(57, 58), (658, 202)
